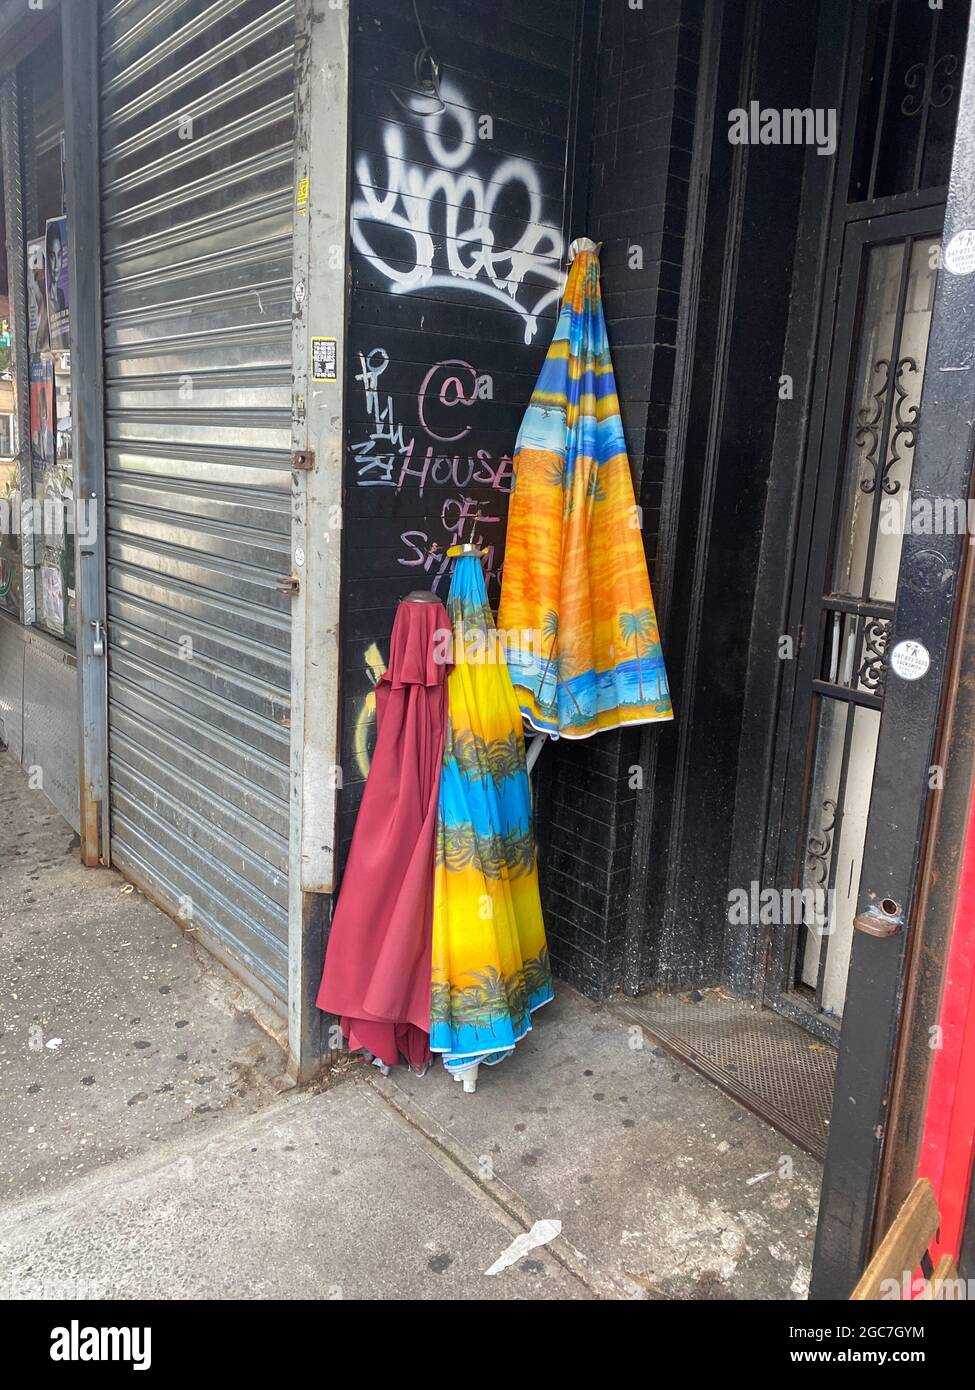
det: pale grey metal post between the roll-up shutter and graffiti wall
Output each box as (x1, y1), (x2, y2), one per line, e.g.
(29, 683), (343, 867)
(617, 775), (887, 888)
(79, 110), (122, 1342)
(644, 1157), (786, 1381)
(288, 0), (352, 1081)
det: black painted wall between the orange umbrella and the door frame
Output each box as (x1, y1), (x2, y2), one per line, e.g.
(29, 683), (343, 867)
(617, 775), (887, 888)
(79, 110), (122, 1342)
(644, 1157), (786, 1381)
(520, 0), (816, 997)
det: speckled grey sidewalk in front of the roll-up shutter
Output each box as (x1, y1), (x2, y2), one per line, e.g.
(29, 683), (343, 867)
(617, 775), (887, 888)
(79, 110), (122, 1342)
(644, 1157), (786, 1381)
(0, 753), (285, 1200)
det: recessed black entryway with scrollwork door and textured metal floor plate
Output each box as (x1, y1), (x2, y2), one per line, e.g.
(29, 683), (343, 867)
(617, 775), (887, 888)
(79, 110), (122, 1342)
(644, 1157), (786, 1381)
(627, 0), (968, 1184)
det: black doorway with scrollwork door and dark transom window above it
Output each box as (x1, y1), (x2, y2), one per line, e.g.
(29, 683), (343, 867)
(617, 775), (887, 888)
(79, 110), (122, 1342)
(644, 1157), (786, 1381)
(755, 0), (968, 1049)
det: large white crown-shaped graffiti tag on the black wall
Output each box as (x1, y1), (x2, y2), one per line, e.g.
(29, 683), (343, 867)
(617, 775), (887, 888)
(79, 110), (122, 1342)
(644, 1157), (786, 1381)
(352, 81), (563, 343)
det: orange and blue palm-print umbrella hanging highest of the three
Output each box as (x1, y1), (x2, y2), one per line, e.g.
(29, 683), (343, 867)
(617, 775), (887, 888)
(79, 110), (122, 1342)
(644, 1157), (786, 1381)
(498, 240), (673, 738)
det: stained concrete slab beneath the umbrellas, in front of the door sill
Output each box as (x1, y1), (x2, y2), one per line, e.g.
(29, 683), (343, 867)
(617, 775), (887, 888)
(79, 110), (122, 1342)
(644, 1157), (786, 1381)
(374, 981), (821, 1300)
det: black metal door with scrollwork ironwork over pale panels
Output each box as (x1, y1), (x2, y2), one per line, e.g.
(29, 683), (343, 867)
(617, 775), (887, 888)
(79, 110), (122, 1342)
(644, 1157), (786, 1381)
(766, 209), (942, 1041)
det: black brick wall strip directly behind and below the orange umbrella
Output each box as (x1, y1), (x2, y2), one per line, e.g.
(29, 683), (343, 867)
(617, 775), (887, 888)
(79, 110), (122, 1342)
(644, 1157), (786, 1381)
(537, 0), (704, 997)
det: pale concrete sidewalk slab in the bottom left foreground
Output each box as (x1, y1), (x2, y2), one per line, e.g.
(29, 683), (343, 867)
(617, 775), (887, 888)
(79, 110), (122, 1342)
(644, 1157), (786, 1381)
(0, 1081), (591, 1300)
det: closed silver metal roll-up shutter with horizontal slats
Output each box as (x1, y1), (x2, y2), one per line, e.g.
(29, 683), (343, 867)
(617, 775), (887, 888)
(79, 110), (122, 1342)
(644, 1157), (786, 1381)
(102, 0), (293, 1005)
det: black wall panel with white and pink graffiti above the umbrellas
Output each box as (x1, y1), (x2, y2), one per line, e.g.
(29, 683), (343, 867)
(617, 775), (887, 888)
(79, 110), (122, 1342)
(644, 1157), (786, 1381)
(341, 0), (581, 847)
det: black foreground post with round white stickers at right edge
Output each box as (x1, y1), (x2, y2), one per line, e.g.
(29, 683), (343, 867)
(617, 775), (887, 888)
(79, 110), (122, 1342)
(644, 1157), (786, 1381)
(811, 5), (975, 1300)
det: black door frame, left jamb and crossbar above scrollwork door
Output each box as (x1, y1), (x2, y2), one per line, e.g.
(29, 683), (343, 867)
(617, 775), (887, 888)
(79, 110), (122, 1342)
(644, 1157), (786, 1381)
(726, 0), (947, 1023)
